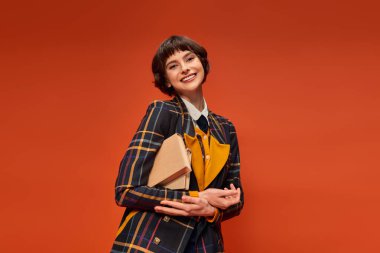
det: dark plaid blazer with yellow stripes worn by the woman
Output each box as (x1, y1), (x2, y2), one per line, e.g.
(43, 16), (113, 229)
(111, 96), (244, 253)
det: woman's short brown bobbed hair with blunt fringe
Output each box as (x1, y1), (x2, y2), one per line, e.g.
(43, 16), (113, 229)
(152, 35), (210, 96)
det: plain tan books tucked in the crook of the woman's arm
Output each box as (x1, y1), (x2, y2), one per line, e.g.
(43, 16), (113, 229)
(148, 134), (191, 189)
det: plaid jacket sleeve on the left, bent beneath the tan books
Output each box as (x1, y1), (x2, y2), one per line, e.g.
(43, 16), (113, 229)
(115, 101), (189, 211)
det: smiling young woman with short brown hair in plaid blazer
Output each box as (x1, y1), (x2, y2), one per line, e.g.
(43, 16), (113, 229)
(111, 36), (244, 253)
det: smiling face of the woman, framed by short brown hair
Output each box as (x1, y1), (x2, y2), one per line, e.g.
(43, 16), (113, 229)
(165, 50), (204, 96)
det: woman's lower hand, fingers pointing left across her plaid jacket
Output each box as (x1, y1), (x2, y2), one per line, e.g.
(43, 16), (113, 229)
(154, 195), (215, 217)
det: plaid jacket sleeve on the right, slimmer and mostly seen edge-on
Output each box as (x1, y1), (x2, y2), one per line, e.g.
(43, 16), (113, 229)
(218, 121), (244, 221)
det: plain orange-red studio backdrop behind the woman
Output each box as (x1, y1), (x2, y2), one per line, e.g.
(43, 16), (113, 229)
(0, 0), (380, 253)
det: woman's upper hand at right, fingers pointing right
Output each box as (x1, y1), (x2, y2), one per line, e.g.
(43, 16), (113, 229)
(199, 184), (240, 210)
